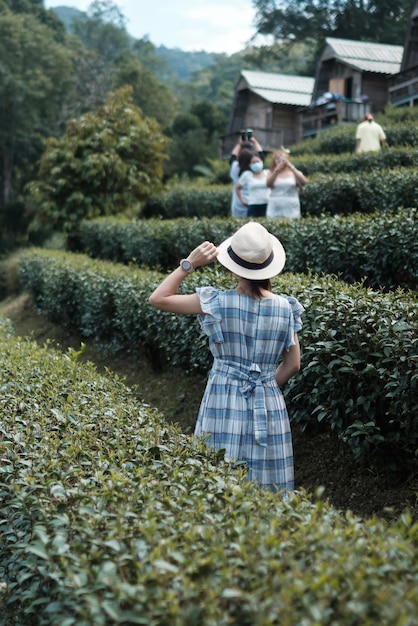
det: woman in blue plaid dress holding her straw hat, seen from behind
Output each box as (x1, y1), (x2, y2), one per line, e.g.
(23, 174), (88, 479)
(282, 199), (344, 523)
(149, 222), (304, 495)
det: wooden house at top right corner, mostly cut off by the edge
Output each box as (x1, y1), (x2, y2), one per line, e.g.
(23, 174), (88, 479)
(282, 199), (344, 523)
(389, 2), (418, 106)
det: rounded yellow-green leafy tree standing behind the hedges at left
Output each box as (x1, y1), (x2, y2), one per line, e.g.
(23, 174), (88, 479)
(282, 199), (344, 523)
(29, 87), (167, 234)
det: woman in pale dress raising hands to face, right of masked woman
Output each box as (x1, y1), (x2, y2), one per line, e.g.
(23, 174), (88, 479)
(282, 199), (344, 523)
(266, 148), (307, 219)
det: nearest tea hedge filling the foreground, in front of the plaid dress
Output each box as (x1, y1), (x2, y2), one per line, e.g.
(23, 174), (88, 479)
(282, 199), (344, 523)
(0, 330), (418, 626)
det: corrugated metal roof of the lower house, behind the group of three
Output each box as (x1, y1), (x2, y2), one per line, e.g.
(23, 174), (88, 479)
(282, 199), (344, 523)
(241, 70), (315, 106)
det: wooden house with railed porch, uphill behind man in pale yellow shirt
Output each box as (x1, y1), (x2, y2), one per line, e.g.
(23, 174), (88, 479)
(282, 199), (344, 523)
(303, 37), (403, 137)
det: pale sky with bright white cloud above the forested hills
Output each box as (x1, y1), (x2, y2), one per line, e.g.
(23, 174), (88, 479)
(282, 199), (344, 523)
(44, 0), (255, 55)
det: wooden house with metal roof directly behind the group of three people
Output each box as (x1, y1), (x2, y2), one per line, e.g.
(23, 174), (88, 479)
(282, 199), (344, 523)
(222, 70), (314, 155)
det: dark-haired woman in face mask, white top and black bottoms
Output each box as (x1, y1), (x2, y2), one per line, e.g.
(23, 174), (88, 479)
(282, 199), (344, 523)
(235, 154), (270, 217)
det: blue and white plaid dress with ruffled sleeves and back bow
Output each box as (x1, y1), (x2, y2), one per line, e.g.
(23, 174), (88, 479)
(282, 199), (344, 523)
(195, 287), (304, 491)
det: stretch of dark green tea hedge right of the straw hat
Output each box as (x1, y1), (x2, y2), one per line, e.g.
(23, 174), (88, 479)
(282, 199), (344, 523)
(284, 209), (418, 290)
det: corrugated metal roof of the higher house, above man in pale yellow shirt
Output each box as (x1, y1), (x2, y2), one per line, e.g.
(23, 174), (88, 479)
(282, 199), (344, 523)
(326, 37), (403, 74)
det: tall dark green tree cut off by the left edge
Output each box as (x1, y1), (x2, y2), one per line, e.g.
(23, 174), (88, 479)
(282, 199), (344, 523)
(0, 10), (71, 244)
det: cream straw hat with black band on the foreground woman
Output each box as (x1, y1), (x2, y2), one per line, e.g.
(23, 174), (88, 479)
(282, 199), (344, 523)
(218, 222), (286, 280)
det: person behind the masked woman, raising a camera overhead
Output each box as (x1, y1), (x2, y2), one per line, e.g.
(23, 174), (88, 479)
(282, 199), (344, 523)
(229, 133), (264, 217)
